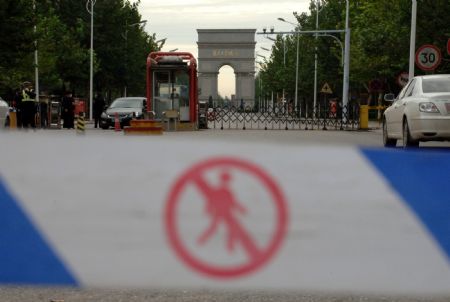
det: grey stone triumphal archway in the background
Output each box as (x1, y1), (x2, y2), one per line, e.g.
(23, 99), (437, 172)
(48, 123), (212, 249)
(197, 29), (256, 105)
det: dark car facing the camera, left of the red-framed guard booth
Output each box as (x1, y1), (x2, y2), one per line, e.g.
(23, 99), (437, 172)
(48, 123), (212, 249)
(100, 97), (147, 129)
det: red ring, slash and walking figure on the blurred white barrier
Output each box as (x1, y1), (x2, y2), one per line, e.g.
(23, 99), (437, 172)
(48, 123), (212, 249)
(164, 157), (288, 278)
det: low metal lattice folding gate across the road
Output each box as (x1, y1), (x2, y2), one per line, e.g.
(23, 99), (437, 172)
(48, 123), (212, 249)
(207, 104), (359, 130)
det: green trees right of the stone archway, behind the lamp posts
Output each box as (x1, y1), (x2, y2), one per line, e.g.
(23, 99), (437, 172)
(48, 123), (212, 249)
(257, 0), (450, 104)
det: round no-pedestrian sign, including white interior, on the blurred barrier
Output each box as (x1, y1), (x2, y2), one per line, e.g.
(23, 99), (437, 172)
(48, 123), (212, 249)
(165, 158), (287, 278)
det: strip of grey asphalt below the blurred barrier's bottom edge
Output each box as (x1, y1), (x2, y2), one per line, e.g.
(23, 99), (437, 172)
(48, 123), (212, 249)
(0, 287), (449, 302)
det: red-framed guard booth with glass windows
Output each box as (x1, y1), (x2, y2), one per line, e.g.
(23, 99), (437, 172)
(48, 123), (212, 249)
(147, 52), (198, 130)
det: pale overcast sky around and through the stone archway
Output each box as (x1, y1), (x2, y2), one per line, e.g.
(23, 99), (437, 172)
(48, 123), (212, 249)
(139, 0), (310, 96)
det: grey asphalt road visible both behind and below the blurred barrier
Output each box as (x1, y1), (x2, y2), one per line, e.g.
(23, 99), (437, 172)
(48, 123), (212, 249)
(0, 124), (450, 302)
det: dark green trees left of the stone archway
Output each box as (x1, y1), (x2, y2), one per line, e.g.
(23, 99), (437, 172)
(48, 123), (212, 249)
(0, 0), (162, 98)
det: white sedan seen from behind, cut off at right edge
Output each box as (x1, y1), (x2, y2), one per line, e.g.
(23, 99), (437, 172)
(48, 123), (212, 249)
(383, 74), (450, 147)
